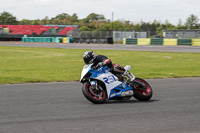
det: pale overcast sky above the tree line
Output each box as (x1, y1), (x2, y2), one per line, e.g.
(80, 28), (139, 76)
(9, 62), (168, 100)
(0, 0), (200, 25)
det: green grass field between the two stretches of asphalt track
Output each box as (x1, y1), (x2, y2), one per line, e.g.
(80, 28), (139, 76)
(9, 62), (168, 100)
(0, 46), (200, 84)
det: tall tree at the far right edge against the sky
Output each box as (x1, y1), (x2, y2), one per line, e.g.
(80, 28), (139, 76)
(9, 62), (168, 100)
(185, 14), (199, 29)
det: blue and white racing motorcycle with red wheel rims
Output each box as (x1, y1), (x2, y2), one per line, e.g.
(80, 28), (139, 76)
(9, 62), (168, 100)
(80, 64), (153, 104)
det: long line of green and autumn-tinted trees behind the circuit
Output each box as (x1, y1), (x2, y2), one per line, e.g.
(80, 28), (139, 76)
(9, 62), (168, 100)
(0, 11), (200, 36)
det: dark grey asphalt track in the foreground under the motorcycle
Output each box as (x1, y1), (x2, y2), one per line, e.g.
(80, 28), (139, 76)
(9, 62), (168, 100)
(0, 78), (200, 133)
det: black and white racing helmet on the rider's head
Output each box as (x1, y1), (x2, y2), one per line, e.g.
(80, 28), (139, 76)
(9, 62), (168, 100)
(83, 51), (96, 64)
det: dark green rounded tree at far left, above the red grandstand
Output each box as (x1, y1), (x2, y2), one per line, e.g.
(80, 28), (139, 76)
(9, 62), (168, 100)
(0, 11), (18, 24)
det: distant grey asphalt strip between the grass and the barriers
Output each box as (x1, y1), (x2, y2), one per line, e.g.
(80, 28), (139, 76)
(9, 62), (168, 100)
(0, 42), (200, 53)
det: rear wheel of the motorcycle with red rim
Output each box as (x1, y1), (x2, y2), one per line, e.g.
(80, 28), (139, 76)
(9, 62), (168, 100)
(133, 78), (153, 101)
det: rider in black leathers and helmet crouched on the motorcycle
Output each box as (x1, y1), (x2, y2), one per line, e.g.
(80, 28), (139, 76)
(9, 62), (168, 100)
(83, 51), (135, 81)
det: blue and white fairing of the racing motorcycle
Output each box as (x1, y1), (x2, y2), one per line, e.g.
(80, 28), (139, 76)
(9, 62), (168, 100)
(80, 65), (132, 99)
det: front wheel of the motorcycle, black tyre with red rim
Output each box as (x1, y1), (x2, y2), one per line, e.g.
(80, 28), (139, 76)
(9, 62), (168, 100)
(82, 82), (106, 104)
